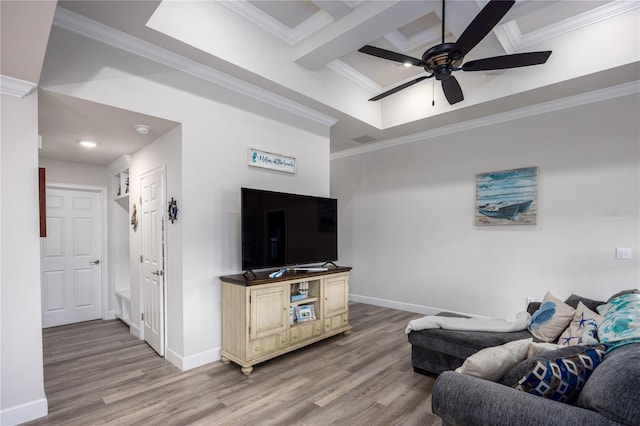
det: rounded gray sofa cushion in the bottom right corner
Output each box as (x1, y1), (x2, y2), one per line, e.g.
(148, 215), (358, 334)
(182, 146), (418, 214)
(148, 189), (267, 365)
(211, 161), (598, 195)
(576, 343), (640, 425)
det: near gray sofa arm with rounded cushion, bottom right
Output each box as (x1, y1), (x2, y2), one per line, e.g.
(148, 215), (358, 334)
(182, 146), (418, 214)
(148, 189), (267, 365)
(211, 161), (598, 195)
(431, 343), (640, 426)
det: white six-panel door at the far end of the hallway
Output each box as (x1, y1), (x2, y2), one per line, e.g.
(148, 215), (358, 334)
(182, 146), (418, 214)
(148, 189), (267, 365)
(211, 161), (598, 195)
(40, 188), (102, 327)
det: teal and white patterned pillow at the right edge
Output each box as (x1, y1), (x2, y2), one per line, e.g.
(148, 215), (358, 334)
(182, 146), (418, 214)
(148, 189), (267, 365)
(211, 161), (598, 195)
(597, 293), (640, 351)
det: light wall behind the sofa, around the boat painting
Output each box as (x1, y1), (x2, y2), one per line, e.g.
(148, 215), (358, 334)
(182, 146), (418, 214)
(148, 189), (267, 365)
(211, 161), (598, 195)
(331, 93), (640, 317)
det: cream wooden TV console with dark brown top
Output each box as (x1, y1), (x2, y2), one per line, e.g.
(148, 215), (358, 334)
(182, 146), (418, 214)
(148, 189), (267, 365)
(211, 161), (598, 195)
(220, 267), (351, 376)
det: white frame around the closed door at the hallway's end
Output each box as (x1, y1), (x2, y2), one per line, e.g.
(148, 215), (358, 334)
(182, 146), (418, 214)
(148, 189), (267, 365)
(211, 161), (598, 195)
(40, 182), (109, 320)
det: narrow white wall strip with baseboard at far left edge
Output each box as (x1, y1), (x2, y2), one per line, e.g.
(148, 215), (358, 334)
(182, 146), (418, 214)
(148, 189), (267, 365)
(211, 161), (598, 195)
(0, 93), (47, 425)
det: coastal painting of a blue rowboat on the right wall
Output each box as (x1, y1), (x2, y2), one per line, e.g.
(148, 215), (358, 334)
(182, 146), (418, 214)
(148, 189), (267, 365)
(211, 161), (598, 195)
(475, 167), (538, 226)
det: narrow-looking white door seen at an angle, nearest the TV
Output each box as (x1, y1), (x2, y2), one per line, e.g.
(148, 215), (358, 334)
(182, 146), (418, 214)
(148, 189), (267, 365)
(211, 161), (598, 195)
(139, 169), (165, 355)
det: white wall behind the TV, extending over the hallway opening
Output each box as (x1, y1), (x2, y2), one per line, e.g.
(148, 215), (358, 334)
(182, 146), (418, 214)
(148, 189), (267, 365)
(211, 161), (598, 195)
(41, 27), (330, 369)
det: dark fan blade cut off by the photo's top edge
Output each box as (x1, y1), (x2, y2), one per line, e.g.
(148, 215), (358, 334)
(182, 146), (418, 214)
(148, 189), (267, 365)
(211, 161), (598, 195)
(449, 0), (515, 61)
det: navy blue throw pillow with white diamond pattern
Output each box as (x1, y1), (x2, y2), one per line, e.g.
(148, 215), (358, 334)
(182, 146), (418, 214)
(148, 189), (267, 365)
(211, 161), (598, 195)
(513, 345), (605, 403)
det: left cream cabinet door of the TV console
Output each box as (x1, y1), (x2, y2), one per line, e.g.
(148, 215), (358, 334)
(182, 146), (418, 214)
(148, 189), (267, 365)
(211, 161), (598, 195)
(249, 286), (289, 340)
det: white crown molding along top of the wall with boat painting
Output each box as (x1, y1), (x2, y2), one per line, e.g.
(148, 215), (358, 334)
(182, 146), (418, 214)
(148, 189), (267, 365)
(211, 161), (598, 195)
(330, 80), (640, 160)
